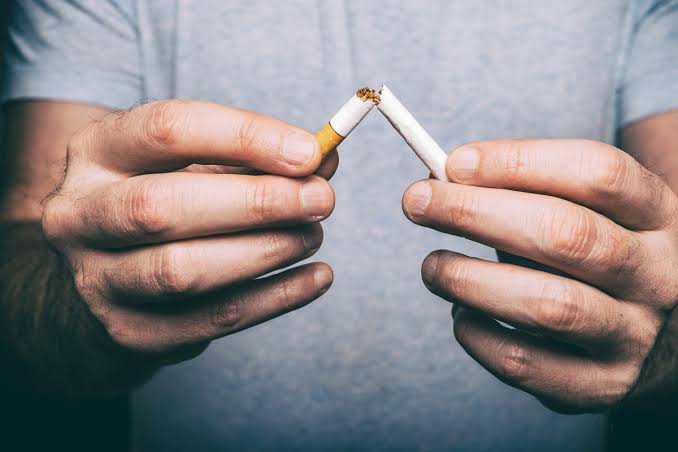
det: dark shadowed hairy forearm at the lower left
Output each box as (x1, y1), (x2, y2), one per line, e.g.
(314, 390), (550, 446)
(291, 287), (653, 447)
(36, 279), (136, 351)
(0, 223), (152, 397)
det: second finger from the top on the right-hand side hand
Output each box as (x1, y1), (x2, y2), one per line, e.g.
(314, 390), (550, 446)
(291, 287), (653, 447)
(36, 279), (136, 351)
(403, 180), (654, 296)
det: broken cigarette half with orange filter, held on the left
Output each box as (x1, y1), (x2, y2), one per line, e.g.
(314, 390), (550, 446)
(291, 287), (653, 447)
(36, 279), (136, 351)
(315, 87), (379, 158)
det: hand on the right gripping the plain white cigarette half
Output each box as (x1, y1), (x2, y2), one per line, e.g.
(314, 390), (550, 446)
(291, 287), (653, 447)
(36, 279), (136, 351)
(403, 140), (678, 412)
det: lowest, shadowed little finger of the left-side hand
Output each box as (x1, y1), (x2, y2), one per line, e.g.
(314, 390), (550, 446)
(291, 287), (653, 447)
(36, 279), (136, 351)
(105, 263), (333, 353)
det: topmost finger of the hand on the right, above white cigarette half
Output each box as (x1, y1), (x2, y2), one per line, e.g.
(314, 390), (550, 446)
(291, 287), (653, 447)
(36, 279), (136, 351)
(446, 140), (676, 230)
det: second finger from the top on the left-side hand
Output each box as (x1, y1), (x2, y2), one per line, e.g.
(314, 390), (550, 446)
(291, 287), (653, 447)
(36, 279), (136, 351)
(68, 173), (334, 248)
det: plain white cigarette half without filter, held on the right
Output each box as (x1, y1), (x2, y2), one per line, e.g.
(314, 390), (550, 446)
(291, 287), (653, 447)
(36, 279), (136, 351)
(377, 85), (448, 182)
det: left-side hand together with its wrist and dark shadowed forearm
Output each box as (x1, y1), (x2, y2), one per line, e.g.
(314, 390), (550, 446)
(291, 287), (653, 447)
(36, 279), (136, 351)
(0, 100), (338, 397)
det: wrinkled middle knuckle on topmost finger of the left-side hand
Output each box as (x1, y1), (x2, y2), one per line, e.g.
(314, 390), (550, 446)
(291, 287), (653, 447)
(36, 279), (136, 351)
(145, 100), (188, 147)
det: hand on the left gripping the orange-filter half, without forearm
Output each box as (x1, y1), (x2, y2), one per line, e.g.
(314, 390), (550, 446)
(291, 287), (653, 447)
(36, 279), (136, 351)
(43, 101), (337, 364)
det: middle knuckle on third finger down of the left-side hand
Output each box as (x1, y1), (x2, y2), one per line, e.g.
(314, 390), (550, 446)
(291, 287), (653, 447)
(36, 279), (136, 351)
(151, 244), (197, 295)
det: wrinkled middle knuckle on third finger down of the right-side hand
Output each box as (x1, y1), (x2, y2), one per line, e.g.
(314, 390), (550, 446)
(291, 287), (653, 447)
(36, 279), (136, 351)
(534, 282), (583, 332)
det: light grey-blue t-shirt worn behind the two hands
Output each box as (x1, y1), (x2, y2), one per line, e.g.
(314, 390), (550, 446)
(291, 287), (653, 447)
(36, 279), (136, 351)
(2, 0), (678, 451)
